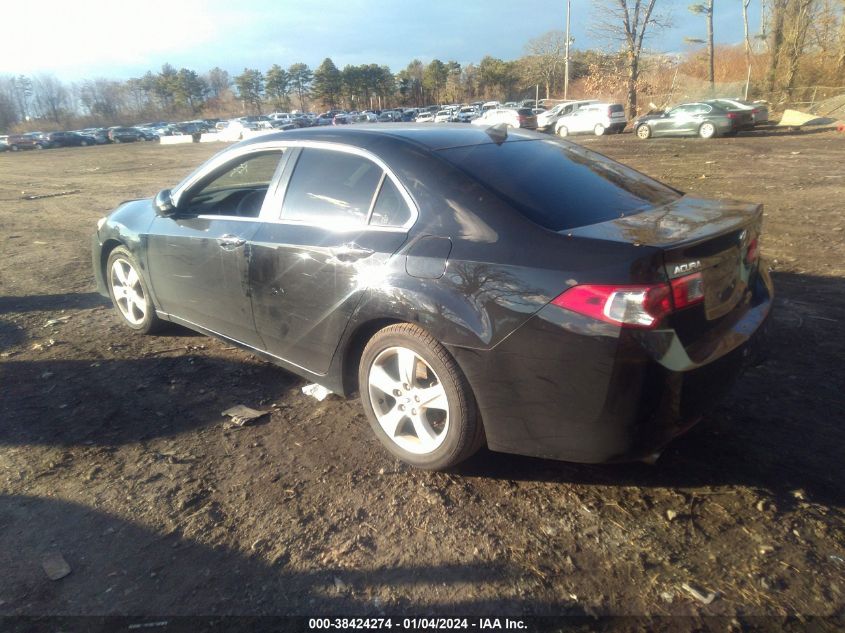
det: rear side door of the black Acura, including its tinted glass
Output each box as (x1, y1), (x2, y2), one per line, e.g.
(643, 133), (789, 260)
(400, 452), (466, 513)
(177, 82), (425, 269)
(250, 146), (417, 373)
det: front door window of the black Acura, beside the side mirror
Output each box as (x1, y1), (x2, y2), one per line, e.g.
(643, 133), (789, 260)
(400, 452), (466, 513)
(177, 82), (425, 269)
(179, 150), (282, 218)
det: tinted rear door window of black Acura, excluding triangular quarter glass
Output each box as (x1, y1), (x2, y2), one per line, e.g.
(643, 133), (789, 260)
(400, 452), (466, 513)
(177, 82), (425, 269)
(282, 147), (382, 226)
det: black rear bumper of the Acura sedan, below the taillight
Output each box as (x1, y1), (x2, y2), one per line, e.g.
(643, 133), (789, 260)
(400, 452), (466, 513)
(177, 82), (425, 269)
(453, 266), (772, 463)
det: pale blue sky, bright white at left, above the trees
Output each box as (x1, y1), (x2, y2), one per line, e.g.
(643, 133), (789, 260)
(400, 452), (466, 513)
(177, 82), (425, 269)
(0, 0), (760, 81)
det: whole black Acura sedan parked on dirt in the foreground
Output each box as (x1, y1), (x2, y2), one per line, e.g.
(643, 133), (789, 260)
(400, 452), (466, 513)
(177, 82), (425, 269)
(93, 124), (772, 468)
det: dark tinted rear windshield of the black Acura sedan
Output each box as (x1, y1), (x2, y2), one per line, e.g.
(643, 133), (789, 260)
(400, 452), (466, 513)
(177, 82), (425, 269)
(440, 140), (680, 231)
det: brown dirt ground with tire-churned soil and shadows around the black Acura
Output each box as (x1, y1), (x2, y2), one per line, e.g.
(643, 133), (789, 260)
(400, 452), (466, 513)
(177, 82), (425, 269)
(0, 131), (845, 630)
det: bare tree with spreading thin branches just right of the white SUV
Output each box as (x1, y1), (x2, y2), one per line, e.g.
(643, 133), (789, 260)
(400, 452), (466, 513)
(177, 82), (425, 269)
(594, 0), (668, 118)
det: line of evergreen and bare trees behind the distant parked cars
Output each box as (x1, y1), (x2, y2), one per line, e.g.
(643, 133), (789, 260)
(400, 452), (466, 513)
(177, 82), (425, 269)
(0, 0), (845, 130)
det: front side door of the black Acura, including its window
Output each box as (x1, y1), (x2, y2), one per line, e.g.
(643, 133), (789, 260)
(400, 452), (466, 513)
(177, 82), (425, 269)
(148, 150), (282, 347)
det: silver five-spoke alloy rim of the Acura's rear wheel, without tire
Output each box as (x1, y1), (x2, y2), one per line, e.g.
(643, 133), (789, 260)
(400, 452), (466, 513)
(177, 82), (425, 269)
(368, 347), (449, 455)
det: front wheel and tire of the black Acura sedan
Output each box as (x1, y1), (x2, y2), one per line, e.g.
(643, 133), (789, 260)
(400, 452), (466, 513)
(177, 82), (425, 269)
(105, 246), (162, 334)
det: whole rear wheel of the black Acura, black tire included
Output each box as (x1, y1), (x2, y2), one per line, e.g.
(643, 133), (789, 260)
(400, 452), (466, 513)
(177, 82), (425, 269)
(358, 323), (484, 470)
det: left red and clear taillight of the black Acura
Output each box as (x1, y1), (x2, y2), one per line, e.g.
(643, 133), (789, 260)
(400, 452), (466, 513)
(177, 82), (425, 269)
(552, 273), (704, 329)
